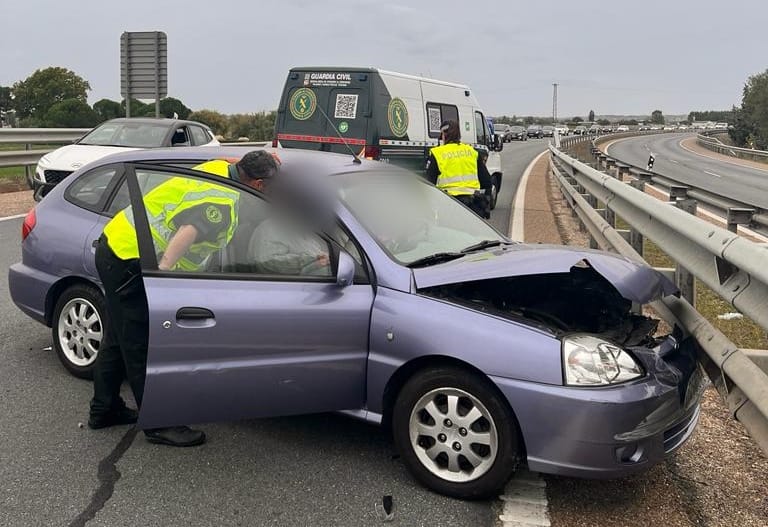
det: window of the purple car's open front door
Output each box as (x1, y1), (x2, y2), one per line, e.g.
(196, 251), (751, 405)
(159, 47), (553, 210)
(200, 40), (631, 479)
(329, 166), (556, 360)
(128, 168), (333, 279)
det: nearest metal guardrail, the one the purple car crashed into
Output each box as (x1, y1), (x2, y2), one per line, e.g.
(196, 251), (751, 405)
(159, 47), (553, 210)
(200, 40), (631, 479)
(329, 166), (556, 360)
(550, 146), (768, 454)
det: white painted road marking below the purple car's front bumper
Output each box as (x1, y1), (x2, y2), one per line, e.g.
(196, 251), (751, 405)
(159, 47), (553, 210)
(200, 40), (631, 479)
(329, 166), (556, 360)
(499, 470), (551, 527)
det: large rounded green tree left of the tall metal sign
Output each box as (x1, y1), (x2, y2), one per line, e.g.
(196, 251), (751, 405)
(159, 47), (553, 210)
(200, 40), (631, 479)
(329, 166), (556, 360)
(11, 67), (91, 122)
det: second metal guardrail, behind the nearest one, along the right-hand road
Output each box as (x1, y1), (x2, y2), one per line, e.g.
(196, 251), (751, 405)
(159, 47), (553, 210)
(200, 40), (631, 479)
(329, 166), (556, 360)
(562, 132), (768, 232)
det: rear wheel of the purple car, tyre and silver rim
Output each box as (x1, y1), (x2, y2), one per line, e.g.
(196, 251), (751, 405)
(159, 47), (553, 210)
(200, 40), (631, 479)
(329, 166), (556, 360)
(51, 284), (107, 379)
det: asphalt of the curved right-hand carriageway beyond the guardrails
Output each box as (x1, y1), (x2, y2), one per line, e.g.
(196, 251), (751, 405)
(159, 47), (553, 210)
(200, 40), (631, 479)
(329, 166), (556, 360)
(608, 133), (768, 208)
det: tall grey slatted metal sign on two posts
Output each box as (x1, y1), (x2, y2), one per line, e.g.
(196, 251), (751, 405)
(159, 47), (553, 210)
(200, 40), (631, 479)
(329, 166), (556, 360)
(120, 31), (168, 117)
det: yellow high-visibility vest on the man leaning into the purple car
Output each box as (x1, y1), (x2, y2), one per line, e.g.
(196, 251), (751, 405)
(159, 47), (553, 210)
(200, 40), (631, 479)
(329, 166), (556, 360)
(104, 177), (240, 271)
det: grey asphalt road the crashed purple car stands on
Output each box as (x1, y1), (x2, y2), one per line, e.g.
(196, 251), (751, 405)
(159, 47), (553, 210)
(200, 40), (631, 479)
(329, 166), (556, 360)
(0, 140), (546, 526)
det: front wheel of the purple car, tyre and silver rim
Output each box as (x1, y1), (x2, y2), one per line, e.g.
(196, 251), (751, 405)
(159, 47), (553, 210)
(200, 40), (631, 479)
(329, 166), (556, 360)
(392, 367), (519, 499)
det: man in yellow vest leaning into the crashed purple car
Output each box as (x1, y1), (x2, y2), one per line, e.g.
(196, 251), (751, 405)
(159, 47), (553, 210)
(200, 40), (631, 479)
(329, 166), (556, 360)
(88, 151), (277, 446)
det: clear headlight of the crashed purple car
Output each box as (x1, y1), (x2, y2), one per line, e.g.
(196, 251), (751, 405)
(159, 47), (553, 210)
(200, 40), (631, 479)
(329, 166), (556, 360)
(563, 335), (645, 386)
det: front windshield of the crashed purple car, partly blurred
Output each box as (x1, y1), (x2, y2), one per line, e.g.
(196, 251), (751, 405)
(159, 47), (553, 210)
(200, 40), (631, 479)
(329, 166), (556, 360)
(339, 173), (507, 265)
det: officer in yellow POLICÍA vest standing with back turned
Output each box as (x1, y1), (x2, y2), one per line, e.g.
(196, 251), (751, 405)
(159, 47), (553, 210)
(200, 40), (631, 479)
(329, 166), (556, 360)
(427, 120), (491, 218)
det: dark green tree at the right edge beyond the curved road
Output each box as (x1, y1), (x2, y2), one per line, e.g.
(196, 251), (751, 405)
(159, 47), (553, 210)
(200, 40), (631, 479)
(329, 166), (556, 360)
(730, 70), (768, 150)
